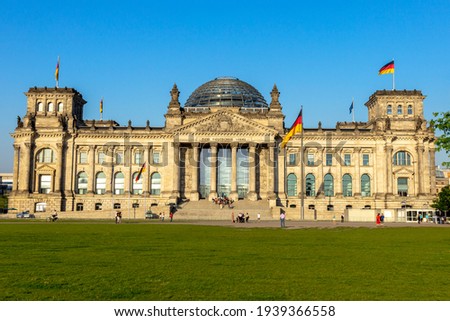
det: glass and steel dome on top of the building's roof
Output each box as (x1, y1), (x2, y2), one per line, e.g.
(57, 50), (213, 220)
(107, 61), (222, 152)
(184, 77), (268, 108)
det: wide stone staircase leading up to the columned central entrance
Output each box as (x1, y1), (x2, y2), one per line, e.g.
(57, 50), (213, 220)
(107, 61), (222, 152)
(175, 200), (273, 221)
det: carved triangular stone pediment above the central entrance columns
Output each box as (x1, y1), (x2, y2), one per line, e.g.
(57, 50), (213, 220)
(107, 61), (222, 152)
(174, 110), (277, 135)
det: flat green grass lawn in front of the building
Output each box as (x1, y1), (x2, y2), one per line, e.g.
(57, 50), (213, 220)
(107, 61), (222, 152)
(0, 222), (450, 301)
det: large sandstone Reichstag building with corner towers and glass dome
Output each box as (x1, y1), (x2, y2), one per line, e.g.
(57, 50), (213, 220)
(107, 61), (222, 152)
(10, 77), (436, 220)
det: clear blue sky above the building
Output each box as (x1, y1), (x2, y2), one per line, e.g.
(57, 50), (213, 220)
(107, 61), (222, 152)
(0, 0), (450, 172)
